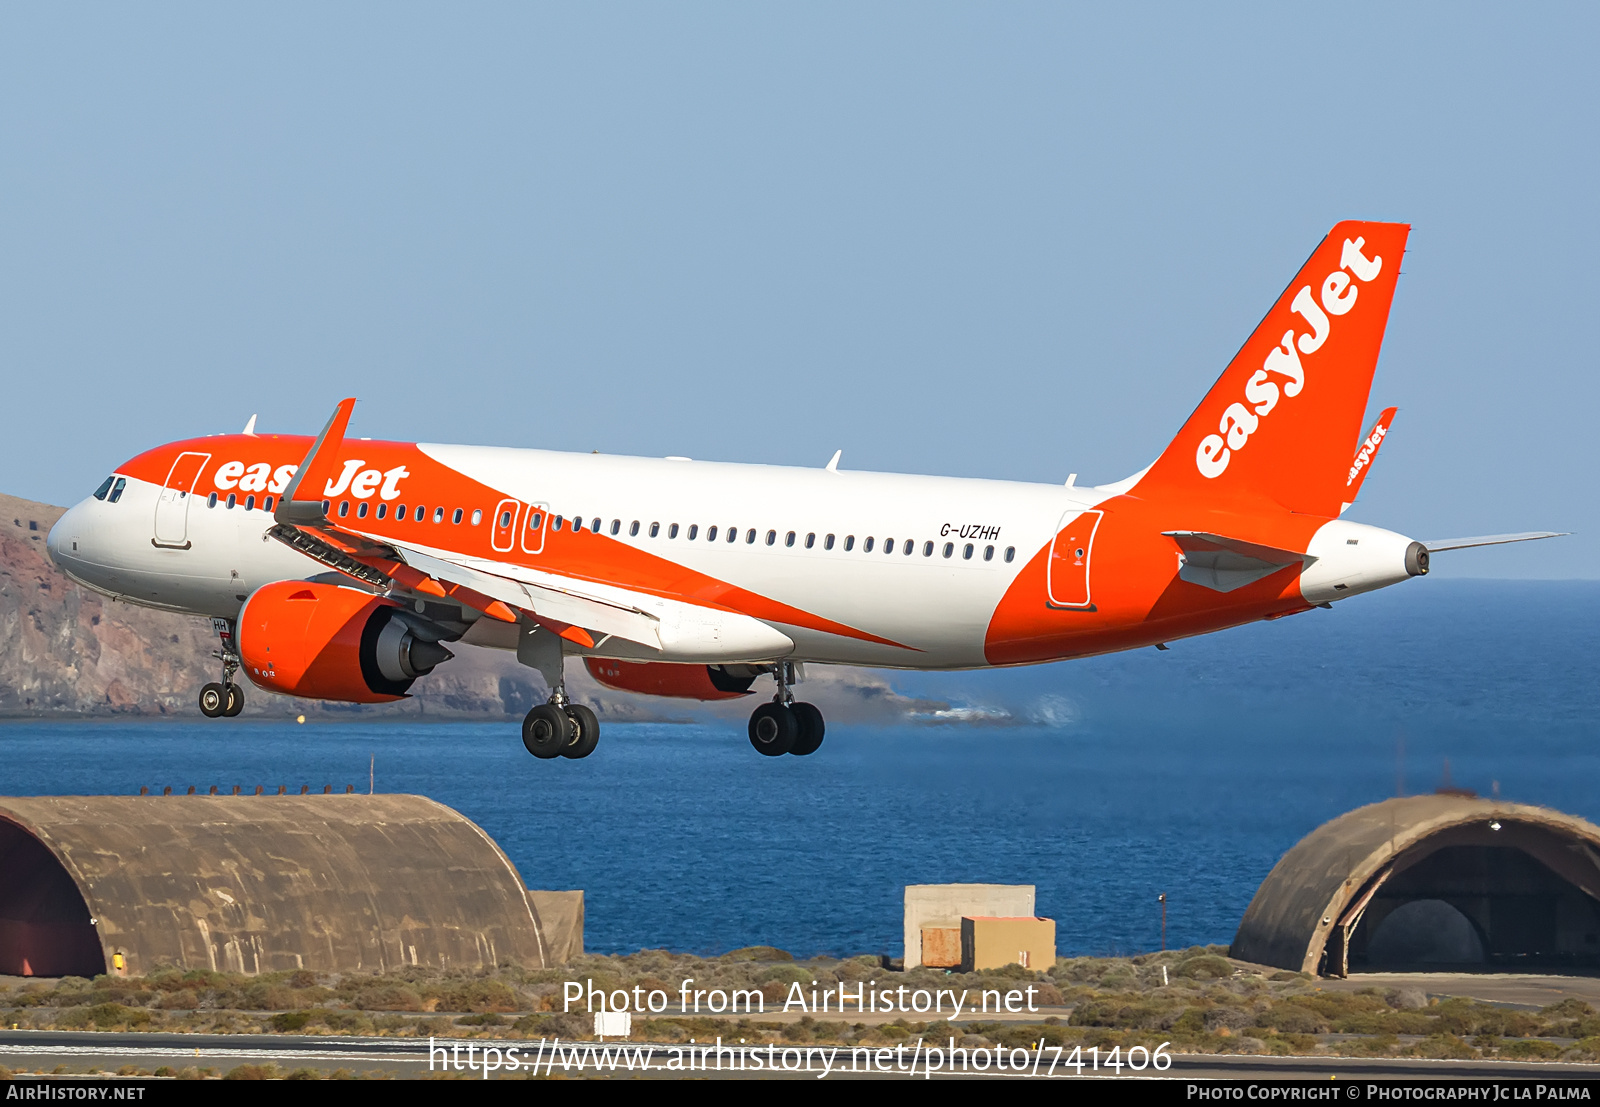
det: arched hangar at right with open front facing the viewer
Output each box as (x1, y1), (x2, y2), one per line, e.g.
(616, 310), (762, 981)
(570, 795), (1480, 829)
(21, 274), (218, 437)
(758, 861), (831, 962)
(1232, 795), (1600, 976)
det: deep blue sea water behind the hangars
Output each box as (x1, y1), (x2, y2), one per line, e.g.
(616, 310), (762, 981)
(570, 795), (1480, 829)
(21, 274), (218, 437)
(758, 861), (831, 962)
(0, 581), (1600, 957)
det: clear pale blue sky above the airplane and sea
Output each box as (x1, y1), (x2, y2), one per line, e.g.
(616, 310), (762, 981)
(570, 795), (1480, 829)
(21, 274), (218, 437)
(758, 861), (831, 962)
(0, 3), (1600, 577)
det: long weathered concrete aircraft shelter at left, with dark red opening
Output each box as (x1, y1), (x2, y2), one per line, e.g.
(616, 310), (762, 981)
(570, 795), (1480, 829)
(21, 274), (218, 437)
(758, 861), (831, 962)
(0, 795), (569, 976)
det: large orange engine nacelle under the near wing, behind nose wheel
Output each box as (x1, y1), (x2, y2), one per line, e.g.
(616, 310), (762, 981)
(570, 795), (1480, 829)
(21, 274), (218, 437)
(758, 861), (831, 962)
(238, 581), (453, 704)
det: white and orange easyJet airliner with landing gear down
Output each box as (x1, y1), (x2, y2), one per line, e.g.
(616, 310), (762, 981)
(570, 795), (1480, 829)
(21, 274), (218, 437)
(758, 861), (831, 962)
(48, 221), (1555, 758)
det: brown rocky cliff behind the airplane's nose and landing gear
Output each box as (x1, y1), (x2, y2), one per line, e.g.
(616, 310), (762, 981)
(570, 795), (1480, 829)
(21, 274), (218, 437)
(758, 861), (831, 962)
(0, 494), (944, 721)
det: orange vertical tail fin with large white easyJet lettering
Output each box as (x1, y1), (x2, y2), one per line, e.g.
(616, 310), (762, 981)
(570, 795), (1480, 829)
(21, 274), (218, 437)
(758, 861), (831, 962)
(1133, 222), (1411, 517)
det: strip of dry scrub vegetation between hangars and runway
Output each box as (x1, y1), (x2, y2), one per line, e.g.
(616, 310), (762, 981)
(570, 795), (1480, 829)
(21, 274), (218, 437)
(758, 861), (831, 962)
(0, 947), (1600, 1077)
